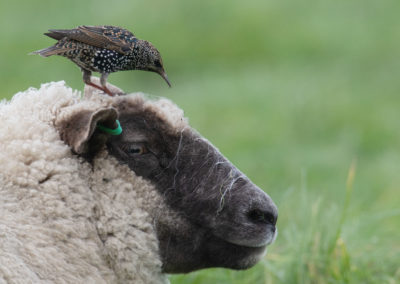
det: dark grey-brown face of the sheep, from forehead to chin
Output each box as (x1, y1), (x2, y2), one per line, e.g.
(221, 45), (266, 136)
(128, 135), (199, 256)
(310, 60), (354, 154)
(107, 98), (277, 273)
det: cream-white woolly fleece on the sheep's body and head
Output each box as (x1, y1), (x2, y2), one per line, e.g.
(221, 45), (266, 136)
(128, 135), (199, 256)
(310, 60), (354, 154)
(0, 82), (170, 283)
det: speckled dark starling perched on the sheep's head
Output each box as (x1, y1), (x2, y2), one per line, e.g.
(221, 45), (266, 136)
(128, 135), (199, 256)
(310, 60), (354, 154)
(31, 26), (171, 96)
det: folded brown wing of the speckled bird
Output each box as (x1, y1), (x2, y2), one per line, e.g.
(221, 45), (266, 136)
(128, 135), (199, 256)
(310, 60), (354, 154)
(45, 26), (137, 54)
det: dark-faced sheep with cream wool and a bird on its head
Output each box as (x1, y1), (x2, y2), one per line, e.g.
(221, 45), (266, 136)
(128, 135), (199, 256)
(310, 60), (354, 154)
(0, 79), (277, 283)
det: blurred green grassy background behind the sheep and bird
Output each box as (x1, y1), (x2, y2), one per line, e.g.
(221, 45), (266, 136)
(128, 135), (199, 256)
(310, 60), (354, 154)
(0, 0), (400, 284)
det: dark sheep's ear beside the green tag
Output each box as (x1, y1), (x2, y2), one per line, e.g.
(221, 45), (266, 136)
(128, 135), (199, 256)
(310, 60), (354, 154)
(59, 108), (118, 155)
